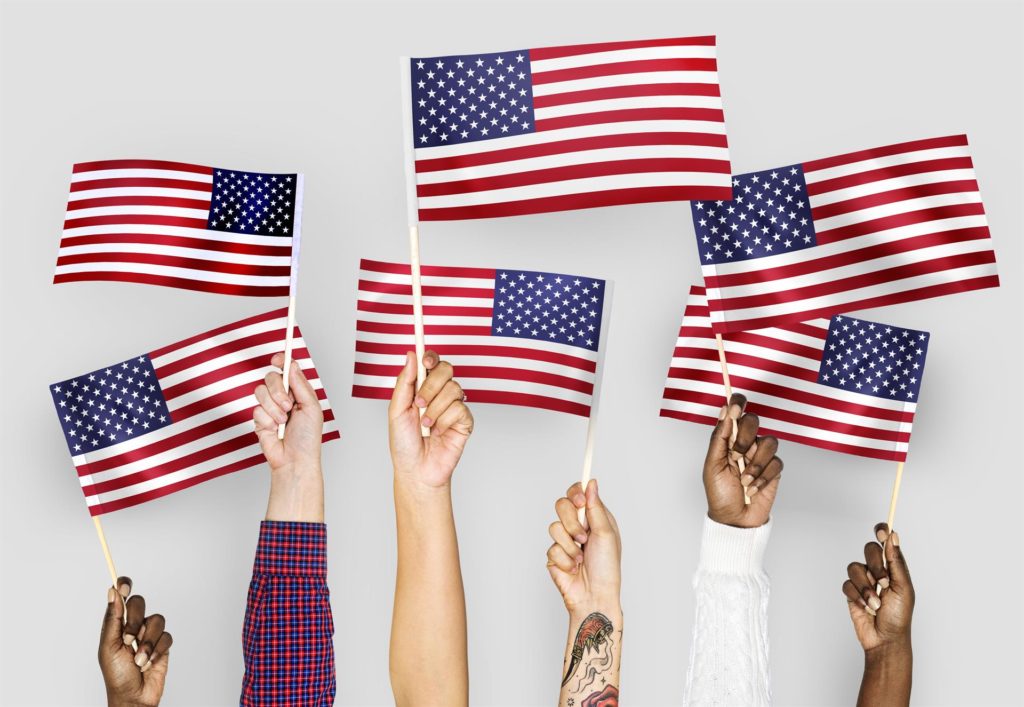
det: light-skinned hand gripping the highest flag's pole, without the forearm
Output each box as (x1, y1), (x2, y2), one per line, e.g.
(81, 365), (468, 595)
(388, 350), (473, 489)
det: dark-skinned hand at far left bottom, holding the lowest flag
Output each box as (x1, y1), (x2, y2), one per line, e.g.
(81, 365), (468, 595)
(97, 577), (172, 707)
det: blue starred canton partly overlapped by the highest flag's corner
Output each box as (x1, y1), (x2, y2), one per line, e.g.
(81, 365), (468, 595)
(690, 165), (816, 265)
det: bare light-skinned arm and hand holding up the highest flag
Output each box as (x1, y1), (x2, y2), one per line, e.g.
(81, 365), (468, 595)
(388, 351), (473, 707)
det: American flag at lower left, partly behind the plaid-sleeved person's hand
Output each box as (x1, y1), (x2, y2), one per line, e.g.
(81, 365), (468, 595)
(50, 309), (339, 515)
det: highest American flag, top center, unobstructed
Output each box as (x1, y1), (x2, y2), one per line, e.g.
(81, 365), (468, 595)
(406, 37), (730, 221)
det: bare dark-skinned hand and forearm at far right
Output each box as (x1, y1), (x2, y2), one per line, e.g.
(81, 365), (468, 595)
(843, 523), (914, 707)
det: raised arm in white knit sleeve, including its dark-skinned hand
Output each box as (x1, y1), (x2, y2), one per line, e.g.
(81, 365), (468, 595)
(685, 394), (782, 705)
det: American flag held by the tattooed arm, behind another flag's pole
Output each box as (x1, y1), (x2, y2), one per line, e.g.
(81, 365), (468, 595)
(352, 259), (606, 416)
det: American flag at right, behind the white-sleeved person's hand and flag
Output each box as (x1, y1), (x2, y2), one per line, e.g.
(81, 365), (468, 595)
(662, 287), (930, 461)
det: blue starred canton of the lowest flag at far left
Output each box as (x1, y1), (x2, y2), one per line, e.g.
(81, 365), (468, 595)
(50, 356), (172, 456)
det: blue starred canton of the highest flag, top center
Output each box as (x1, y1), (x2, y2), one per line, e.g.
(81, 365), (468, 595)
(411, 49), (535, 148)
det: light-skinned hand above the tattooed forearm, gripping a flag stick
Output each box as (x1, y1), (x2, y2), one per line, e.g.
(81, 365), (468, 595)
(548, 479), (623, 615)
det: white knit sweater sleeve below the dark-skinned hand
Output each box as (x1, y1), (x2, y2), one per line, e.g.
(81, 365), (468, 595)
(685, 517), (771, 707)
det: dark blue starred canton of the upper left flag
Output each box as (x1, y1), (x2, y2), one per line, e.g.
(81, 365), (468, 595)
(206, 169), (297, 238)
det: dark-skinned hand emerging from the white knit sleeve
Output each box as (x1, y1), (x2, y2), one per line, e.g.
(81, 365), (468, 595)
(703, 392), (782, 528)
